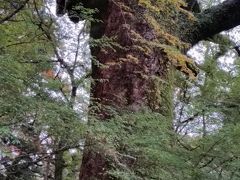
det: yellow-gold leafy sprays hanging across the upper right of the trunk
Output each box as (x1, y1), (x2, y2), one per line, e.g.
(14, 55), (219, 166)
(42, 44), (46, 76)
(125, 0), (198, 79)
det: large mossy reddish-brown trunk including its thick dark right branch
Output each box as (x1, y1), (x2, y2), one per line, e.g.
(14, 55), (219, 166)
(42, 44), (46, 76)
(56, 0), (240, 180)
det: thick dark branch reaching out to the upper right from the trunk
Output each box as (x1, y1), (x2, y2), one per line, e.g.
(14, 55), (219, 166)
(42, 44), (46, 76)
(188, 0), (240, 44)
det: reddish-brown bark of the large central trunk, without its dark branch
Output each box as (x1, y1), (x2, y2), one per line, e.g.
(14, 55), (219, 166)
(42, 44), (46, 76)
(80, 0), (194, 180)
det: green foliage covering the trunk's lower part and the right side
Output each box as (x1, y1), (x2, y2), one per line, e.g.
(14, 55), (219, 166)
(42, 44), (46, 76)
(86, 27), (240, 180)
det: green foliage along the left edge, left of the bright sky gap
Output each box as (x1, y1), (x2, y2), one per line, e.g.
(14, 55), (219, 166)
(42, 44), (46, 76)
(0, 1), (85, 179)
